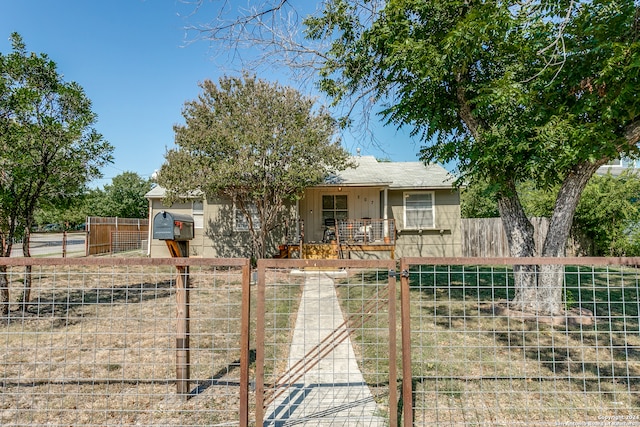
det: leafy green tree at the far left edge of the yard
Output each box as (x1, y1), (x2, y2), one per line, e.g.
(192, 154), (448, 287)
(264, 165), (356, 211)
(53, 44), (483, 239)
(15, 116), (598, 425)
(0, 33), (113, 314)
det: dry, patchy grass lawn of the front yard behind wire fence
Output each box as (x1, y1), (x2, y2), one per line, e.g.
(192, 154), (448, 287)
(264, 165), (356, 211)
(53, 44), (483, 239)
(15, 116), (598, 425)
(5, 266), (640, 426)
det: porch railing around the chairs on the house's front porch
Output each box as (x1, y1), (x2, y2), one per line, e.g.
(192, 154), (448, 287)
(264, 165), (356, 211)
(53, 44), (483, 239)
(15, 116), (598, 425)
(337, 218), (396, 245)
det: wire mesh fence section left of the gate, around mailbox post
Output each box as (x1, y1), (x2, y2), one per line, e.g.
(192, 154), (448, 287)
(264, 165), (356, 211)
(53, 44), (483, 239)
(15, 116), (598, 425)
(0, 259), (248, 426)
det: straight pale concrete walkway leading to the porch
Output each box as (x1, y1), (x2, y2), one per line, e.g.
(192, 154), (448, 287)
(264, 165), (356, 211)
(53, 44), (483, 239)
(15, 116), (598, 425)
(264, 271), (387, 427)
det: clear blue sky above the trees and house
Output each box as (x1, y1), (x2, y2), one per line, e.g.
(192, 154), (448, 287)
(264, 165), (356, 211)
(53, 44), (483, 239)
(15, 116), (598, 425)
(0, 0), (430, 187)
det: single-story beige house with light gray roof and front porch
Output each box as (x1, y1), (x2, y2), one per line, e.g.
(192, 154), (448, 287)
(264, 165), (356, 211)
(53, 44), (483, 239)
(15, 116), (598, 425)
(145, 156), (461, 258)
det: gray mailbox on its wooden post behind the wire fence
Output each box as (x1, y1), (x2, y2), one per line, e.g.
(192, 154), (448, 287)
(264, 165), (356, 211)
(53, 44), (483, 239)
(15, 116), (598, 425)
(153, 211), (193, 400)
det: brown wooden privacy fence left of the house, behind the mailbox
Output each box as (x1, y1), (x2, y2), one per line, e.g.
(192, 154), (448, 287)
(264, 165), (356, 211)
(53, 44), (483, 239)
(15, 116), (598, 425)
(86, 216), (149, 256)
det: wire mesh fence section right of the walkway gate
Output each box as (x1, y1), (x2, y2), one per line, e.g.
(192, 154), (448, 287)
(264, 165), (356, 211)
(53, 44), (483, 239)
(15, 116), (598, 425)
(407, 259), (640, 426)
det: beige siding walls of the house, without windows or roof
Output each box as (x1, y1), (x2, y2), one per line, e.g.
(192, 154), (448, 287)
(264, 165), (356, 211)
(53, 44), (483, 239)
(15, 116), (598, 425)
(151, 187), (462, 258)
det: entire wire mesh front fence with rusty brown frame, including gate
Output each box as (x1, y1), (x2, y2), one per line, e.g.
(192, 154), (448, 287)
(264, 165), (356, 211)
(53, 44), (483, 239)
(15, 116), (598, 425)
(0, 257), (640, 427)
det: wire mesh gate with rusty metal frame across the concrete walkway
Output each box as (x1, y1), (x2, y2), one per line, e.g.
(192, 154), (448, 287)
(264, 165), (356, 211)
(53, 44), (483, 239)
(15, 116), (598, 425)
(255, 260), (398, 426)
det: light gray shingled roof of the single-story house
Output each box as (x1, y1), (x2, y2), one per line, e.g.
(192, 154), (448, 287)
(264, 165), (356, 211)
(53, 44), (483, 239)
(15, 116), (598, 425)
(145, 156), (455, 199)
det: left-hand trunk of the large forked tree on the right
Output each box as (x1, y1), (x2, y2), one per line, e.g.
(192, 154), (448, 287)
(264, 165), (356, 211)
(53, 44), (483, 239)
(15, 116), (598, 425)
(498, 182), (538, 311)
